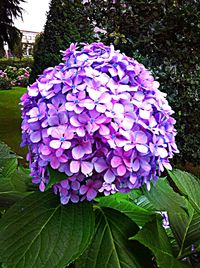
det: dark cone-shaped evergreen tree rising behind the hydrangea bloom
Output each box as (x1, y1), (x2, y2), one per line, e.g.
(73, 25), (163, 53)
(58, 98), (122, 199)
(31, 0), (94, 81)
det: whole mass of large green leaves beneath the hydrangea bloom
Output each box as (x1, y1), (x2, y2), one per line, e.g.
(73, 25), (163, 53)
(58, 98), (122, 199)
(0, 143), (200, 268)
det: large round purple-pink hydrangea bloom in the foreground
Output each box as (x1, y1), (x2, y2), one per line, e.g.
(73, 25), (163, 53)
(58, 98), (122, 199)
(21, 43), (178, 204)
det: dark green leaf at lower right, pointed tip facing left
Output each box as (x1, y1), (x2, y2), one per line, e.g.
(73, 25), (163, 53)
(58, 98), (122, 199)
(131, 218), (190, 268)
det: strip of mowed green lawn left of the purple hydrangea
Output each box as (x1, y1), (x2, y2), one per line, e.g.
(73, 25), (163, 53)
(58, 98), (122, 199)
(0, 87), (27, 157)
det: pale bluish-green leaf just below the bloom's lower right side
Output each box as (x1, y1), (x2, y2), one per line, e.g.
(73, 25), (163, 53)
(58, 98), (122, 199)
(144, 178), (187, 213)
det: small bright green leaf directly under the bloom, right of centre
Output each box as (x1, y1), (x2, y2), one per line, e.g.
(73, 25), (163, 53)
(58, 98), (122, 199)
(99, 194), (155, 226)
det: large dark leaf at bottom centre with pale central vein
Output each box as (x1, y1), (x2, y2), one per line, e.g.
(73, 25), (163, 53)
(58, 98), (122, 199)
(76, 208), (152, 268)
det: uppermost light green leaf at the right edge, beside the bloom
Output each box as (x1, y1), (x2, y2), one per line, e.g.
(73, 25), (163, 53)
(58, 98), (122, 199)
(169, 169), (200, 213)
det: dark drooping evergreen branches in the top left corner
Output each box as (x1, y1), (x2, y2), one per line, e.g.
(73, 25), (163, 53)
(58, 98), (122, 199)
(0, 0), (25, 50)
